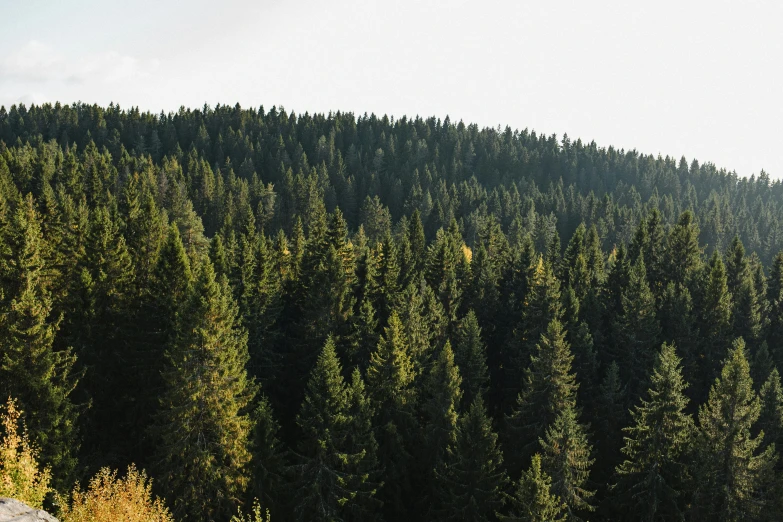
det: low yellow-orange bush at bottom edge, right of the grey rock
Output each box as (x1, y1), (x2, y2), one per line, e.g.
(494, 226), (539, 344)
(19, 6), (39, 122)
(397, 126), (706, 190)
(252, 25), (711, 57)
(60, 465), (174, 522)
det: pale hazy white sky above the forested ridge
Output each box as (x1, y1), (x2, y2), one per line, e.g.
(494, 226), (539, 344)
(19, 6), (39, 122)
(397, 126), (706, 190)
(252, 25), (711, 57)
(0, 0), (783, 178)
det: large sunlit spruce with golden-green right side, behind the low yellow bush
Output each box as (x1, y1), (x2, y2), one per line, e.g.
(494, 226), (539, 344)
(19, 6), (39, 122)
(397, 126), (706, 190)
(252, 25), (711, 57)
(154, 262), (256, 520)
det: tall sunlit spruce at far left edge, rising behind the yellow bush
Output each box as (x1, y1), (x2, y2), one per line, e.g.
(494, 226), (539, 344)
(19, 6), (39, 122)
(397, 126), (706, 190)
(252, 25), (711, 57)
(0, 196), (78, 486)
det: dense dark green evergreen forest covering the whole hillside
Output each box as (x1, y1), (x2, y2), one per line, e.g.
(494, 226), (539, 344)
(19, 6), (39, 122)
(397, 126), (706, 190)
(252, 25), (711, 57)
(0, 104), (783, 522)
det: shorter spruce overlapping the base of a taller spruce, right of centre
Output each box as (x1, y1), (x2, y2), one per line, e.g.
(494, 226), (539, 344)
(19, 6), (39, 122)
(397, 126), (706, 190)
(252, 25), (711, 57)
(539, 406), (595, 520)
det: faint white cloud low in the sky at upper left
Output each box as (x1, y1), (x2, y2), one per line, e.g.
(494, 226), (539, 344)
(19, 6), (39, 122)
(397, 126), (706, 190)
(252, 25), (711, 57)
(0, 40), (160, 84)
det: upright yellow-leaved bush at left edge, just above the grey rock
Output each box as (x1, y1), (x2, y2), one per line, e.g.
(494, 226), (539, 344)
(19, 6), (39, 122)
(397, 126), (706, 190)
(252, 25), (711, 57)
(0, 398), (51, 509)
